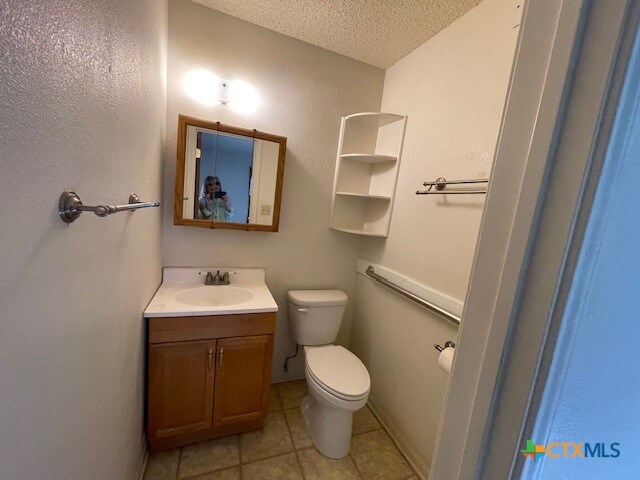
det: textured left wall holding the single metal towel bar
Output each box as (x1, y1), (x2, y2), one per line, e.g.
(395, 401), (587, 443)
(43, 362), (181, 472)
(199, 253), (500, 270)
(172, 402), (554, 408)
(0, 0), (167, 480)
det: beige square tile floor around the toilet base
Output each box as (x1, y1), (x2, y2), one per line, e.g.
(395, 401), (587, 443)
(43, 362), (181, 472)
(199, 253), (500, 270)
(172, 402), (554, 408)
(144, 380), (418, 480)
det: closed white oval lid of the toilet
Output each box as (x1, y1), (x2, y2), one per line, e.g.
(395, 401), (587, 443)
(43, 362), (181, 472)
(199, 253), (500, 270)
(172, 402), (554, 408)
(305, 345), (371, 397)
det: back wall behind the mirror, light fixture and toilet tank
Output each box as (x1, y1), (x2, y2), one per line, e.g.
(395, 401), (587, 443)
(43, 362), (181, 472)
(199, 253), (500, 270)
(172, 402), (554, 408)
(163, 0), (384, 382)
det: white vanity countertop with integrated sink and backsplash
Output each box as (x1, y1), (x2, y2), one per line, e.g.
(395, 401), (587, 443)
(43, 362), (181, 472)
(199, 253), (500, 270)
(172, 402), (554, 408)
(144, 267), (278, 317)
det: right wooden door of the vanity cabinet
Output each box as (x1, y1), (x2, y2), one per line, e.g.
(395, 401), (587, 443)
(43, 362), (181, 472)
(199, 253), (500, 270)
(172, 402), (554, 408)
(213, 335), (273, 426)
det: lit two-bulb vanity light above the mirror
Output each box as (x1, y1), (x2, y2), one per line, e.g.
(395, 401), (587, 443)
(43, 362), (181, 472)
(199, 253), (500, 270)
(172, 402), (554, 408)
(182, 69), (260, 114)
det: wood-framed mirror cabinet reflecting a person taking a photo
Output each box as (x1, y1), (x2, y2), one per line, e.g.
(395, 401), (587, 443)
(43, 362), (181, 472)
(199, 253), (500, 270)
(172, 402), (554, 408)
(174, 115), (287, 232)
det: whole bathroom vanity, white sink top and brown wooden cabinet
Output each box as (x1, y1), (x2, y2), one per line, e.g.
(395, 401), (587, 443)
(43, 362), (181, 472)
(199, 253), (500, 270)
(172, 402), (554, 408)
(145, 268), (278, 451)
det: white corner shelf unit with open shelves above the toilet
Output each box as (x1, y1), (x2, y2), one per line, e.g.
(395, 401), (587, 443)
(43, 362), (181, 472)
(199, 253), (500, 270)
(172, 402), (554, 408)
(330, 112), (407, 237)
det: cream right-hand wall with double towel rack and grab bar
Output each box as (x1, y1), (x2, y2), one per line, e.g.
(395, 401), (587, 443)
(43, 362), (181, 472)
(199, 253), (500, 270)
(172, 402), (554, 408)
(351, 0), (518, 469)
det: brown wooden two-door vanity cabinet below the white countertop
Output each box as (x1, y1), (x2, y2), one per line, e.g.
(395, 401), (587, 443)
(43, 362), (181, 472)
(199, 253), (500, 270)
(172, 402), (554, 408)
(147, 313), (275, 451)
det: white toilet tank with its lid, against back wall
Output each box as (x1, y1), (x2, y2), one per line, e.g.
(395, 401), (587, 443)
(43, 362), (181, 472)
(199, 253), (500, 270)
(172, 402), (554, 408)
(287, 290), (349, 345)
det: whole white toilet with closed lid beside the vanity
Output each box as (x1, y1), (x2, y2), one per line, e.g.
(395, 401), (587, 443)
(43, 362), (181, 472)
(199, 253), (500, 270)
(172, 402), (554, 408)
(287, 290), (371, 458)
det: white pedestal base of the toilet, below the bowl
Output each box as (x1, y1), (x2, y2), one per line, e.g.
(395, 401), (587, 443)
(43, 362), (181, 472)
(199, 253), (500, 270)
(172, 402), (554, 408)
(300, 395), (353, 458)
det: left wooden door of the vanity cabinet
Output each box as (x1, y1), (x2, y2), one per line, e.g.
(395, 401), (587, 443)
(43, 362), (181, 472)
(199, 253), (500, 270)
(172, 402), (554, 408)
(148, 340), (216, 439)
